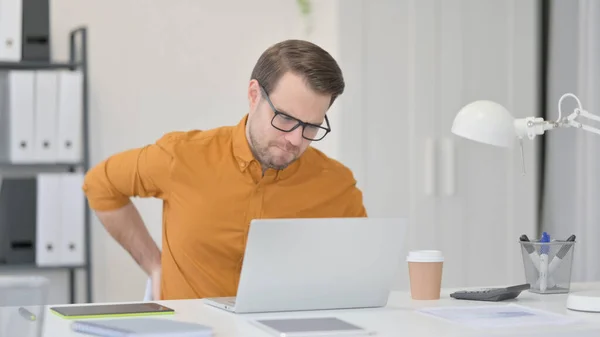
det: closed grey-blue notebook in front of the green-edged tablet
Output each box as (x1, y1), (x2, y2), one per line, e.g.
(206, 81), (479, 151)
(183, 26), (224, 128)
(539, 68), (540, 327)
(71, 318), (213, 337)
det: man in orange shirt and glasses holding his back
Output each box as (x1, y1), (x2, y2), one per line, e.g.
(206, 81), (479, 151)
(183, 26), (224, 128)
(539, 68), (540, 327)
(83, 40), (367, 299)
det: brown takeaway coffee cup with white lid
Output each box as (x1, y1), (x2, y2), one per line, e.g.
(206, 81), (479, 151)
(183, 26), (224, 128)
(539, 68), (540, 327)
(406, 250), (444, 300)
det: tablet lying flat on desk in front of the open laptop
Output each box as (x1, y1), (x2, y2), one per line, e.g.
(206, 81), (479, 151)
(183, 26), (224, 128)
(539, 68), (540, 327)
(255, 317), (375, 337)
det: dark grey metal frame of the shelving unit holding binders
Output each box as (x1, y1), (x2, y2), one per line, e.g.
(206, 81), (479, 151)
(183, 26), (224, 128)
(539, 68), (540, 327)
(0, 27), (92, 303)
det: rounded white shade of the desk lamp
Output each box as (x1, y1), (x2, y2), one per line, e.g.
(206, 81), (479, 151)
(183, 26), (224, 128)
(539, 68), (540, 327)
(452, 100), (517, 147)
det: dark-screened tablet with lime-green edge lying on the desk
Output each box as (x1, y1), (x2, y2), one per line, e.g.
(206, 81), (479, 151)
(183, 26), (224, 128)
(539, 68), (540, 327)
(50, 302), (175, 319)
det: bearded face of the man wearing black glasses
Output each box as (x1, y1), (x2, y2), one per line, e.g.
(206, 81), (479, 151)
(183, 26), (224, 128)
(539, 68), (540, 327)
(246, 72), (331, 170)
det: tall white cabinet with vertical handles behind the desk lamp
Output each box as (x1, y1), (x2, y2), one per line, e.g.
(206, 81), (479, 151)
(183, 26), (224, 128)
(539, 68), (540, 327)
(340, 0), (539, 289)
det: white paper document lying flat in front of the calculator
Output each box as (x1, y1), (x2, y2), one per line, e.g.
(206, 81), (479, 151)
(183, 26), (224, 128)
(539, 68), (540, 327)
(418, 304), (577, 328)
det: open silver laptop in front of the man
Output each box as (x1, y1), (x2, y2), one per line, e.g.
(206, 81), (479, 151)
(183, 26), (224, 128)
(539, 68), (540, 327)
(203, 218), (407, 313)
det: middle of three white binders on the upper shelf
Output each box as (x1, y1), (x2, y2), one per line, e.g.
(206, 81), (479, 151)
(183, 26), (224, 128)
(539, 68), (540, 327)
(33, 70), (58, 163)
